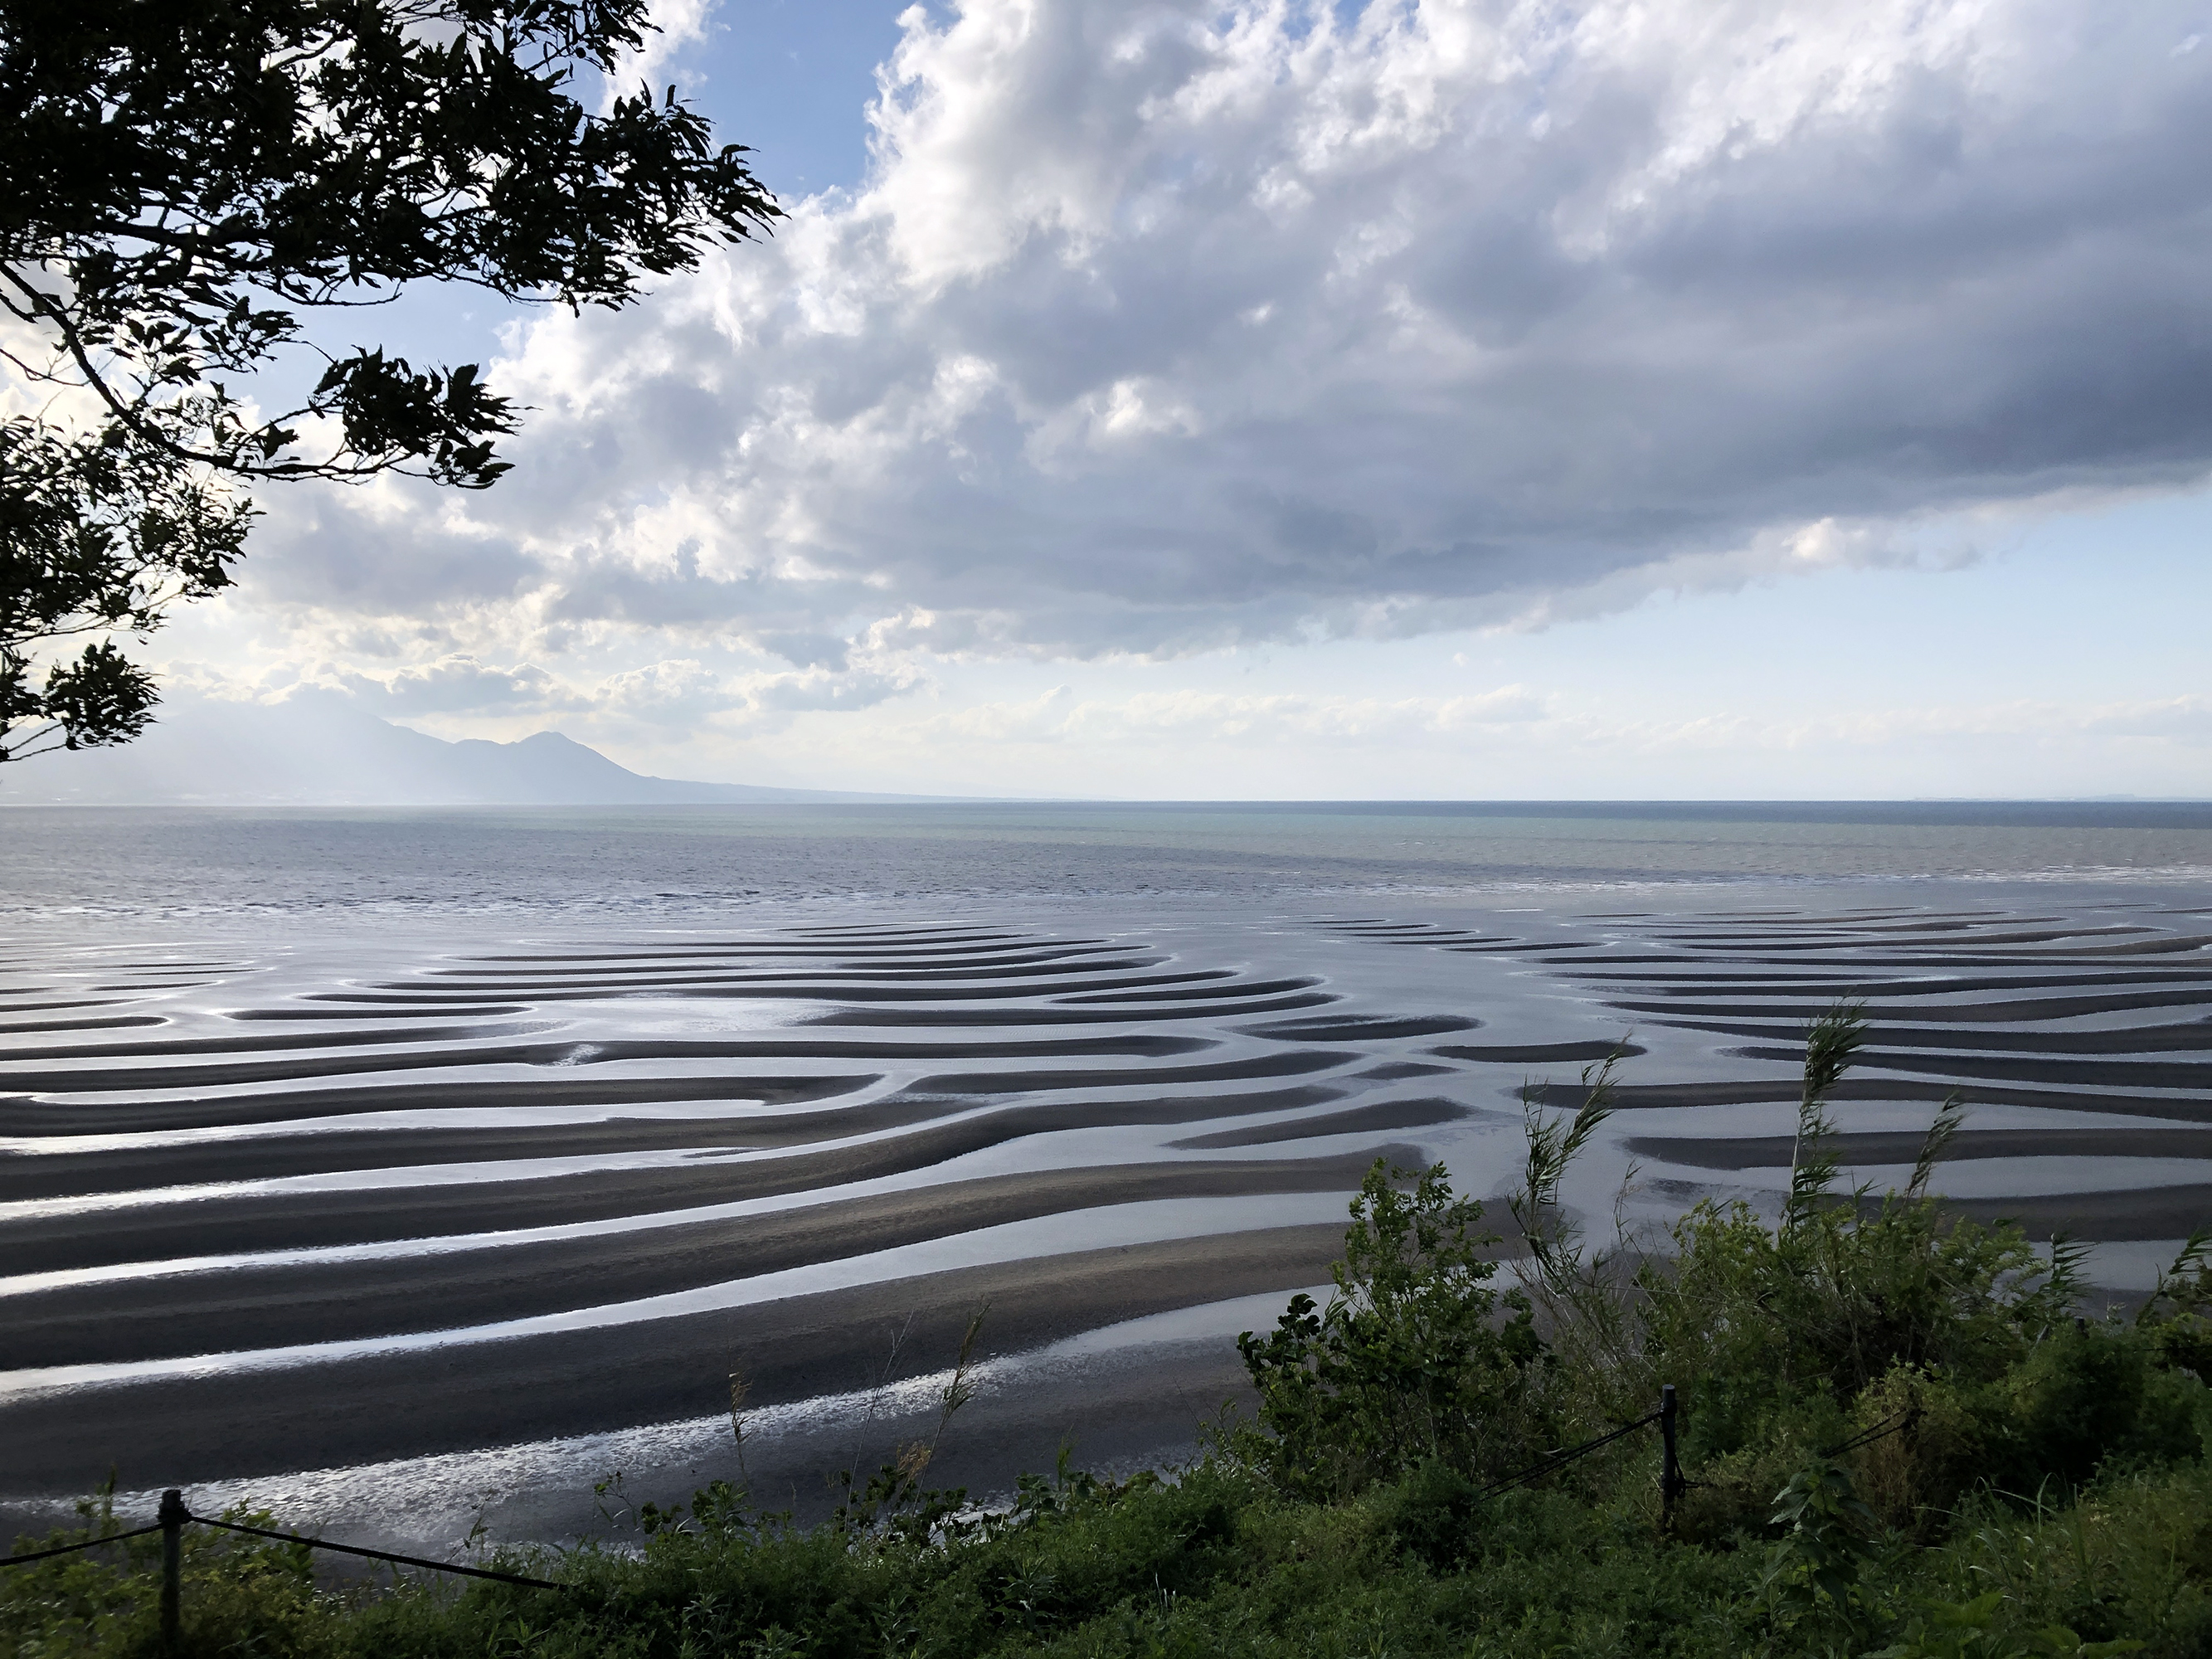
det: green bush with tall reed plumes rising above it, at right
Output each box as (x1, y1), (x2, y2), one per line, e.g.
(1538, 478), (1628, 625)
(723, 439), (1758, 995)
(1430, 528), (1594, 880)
(1513, 1006), (2082, 1462)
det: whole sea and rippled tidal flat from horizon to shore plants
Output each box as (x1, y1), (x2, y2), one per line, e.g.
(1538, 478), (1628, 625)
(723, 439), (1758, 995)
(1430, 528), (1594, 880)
(0, 800), (2212, 1549)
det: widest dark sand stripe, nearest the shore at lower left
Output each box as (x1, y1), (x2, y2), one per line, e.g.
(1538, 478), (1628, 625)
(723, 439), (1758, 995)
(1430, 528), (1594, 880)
(0, 1224), (1345, 1496)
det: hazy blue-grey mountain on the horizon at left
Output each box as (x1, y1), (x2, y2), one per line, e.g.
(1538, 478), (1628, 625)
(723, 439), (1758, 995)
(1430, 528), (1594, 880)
(0, 693), (931, 807)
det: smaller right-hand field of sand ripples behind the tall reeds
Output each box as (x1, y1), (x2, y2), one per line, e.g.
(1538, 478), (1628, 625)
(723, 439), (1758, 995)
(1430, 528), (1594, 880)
(1336, 902), (2212, 1258)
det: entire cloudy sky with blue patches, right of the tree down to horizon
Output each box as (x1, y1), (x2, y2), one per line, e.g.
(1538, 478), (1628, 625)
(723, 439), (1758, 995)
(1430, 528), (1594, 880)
(157, 0), (2212, 799)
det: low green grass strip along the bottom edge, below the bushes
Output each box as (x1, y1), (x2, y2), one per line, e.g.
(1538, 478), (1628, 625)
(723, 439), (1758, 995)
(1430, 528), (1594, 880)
(17, 1457), (2212, 1659)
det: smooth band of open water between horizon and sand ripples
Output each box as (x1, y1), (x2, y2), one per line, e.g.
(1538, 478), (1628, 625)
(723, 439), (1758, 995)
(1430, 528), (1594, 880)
(0, 803), (2212, 920)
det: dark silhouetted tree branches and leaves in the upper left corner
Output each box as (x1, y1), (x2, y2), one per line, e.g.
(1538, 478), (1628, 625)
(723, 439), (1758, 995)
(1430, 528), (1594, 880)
(0, 0), (780, 761)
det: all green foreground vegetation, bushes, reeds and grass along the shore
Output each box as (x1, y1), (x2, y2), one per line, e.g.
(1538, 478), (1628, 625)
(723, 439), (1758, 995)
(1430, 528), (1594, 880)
(0, 1011), (2212, 1659)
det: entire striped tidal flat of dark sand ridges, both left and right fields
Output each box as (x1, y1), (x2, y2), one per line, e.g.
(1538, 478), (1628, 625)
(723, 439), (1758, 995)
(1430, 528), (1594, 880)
(0, 887), (2212, 1521)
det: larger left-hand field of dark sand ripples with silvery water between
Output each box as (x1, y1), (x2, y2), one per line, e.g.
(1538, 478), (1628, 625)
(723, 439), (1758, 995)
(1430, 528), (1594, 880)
(0, 925), (1475, 1489)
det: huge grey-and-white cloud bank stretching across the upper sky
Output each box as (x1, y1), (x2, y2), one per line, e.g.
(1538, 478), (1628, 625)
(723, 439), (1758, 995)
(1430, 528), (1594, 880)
(233, 0), (2212, 690)
